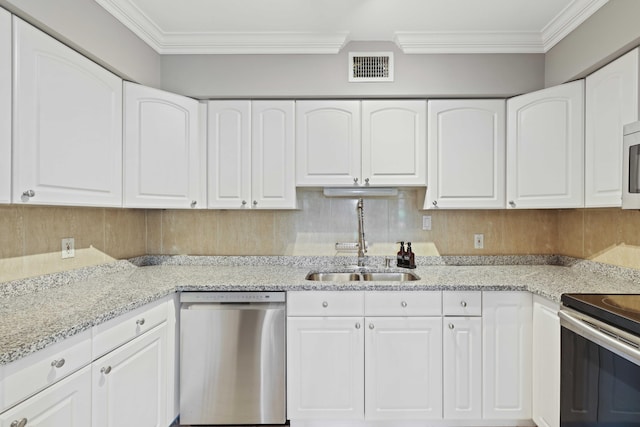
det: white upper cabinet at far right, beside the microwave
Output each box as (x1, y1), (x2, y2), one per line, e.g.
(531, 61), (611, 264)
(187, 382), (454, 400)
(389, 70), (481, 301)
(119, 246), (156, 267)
(584, 49), (639, 207)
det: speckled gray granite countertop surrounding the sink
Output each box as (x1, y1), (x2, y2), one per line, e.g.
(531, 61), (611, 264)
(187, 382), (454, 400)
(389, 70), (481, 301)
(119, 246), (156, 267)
(0, 257), (640, 365)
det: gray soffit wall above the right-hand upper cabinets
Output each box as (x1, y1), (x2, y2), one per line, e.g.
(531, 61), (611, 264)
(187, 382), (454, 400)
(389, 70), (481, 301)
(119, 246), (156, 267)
(545, 0), (640, 86)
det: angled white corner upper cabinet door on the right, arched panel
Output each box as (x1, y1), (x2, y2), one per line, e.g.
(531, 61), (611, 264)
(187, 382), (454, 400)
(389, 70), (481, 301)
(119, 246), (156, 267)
(507, 80), (584, 208)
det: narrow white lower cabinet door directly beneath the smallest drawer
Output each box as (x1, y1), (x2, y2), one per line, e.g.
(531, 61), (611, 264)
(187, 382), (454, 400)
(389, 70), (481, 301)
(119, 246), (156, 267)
(442, 317), (482, 420)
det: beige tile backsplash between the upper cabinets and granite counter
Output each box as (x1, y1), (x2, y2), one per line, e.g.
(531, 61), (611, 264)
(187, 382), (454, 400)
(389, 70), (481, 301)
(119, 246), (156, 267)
(0, 189), (640, 281)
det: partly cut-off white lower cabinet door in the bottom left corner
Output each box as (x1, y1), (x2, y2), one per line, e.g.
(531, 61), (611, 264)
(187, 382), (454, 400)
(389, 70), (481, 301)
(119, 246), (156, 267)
(0, 366), (91, 427)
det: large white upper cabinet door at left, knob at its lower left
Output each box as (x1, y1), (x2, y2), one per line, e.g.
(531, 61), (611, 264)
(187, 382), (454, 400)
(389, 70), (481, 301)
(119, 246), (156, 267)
(13, 18), (122, 206)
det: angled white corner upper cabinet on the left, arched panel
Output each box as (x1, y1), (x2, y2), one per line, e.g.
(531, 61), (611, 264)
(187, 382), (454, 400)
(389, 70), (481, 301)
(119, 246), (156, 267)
(124, 82), (207, 209)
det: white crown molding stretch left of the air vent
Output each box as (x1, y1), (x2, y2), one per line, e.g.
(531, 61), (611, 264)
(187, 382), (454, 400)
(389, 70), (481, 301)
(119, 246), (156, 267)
(95, 0), (349, 55)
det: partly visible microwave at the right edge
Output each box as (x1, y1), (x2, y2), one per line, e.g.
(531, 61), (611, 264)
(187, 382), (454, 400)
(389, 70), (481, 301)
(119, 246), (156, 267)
(622, 122), (640, 209)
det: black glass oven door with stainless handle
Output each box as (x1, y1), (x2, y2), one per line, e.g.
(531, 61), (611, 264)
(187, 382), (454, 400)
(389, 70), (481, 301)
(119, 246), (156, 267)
(559, 308), (640, 427)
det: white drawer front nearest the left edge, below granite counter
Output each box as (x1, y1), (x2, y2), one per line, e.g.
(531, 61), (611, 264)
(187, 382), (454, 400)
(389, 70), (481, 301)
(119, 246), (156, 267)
(0, 331), (91, 412)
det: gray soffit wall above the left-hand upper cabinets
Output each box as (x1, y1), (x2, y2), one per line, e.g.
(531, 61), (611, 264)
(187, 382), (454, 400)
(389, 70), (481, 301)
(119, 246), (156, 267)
(0, 0), (160, 87)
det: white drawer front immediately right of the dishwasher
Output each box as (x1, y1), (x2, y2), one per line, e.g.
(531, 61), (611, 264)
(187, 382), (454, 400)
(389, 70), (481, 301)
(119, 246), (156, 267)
(287, 291), (364, 316)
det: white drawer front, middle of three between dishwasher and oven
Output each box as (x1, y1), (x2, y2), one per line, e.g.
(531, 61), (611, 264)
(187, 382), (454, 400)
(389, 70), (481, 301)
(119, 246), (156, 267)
(365, 291), (442, 316)
